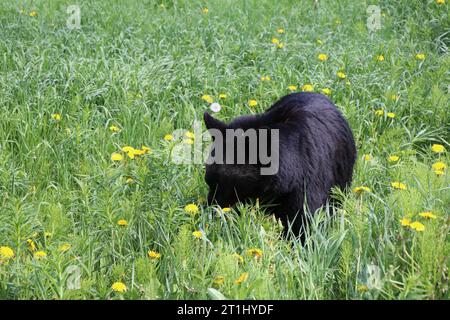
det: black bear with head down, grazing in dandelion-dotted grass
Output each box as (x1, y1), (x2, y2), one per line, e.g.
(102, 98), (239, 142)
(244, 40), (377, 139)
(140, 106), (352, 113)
(204, 92), (356, 234)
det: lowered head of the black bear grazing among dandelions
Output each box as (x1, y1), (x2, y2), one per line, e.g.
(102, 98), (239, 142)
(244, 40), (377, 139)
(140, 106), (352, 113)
(204, 112), (278, 207)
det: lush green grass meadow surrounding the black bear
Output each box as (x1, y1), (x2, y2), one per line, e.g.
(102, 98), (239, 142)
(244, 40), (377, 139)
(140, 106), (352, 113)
(0, 0), (450, 299)
